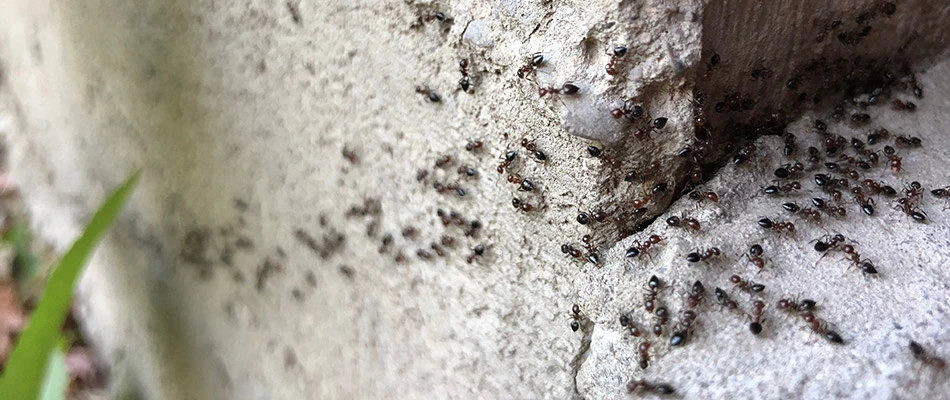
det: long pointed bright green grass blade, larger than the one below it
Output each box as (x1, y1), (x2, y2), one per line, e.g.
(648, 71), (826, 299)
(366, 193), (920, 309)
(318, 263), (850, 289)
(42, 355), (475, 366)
(0, 172), (140, 400)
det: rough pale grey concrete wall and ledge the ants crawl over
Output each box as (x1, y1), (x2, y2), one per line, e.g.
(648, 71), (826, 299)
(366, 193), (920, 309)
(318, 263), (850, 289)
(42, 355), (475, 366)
(0, 1), (950, 399)
